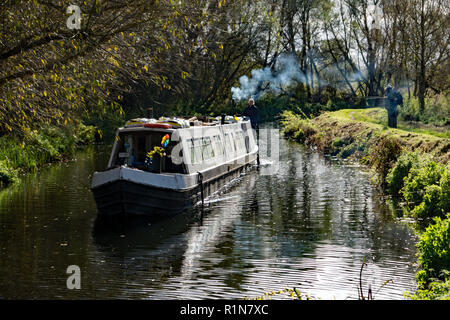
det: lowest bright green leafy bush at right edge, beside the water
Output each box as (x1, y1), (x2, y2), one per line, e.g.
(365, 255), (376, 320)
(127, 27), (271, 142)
(416, 213), (450, 289)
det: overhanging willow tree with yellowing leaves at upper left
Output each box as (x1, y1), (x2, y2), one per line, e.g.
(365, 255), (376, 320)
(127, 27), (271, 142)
(0, 0), (198, 134)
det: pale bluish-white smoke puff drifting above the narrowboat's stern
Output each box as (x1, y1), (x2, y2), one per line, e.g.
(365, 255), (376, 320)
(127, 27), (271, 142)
(231, 54), (305, 100)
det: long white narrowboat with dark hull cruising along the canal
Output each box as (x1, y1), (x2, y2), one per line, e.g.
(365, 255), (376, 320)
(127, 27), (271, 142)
(91, 116), (258, 219)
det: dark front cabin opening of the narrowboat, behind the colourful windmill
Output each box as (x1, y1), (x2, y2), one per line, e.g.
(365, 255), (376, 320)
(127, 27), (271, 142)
(115, 132), (185, 173)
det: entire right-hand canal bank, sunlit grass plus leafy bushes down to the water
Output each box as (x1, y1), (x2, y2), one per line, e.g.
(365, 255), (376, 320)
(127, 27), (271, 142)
(282, 108), (450, 299)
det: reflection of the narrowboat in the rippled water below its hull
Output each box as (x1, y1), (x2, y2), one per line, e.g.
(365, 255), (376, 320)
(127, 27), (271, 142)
(93, 171), (253, 298)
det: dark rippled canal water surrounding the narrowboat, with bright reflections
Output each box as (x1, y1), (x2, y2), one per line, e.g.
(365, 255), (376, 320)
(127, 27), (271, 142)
(0, 127), (417, 299)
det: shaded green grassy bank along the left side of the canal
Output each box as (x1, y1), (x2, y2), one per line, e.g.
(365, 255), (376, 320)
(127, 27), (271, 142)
(0, 123), (97, 187)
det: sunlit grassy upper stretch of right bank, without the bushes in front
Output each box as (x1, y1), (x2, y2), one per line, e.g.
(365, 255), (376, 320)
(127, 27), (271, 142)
(282, 108), (450, 163)
